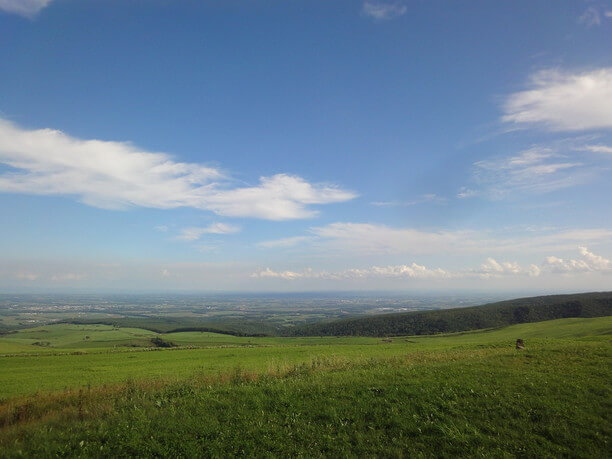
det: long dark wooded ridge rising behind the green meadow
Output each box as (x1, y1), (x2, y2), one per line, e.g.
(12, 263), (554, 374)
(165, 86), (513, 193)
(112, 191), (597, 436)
(287, 292), (612, 336)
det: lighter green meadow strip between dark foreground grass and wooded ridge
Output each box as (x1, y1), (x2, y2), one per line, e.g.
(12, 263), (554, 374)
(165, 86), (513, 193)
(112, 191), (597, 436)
(0, 317), (612, 399)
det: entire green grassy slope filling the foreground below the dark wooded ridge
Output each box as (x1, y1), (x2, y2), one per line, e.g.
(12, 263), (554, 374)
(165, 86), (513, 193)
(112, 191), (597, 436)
(0, 317), (612, 457)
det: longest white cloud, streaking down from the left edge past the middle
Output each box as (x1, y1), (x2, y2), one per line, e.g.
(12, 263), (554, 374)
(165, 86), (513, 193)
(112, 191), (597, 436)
(0, 120), (355, 220)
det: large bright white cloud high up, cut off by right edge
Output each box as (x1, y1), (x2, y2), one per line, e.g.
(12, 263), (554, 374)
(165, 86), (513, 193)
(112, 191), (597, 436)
(502, 67), (612, 131)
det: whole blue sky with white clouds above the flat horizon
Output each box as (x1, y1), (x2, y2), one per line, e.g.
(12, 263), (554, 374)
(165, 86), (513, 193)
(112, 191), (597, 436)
(0, 0), (612, 293)
